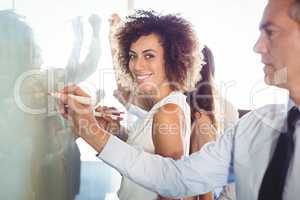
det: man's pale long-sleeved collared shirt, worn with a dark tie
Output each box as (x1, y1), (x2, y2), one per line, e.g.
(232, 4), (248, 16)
(99, 105), (300, 200)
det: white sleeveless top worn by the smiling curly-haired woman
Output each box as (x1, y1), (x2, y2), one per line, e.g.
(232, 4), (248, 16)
(118, 91), (191, 200)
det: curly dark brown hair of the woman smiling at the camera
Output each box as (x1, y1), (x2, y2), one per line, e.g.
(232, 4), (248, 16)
(116, 10), (200, 90)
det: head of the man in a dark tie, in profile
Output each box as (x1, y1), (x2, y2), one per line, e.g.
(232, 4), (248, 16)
(254, 0), (300, 92)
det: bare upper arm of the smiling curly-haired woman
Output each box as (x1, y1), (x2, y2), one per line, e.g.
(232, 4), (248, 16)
(152, 104), (185, 200)
